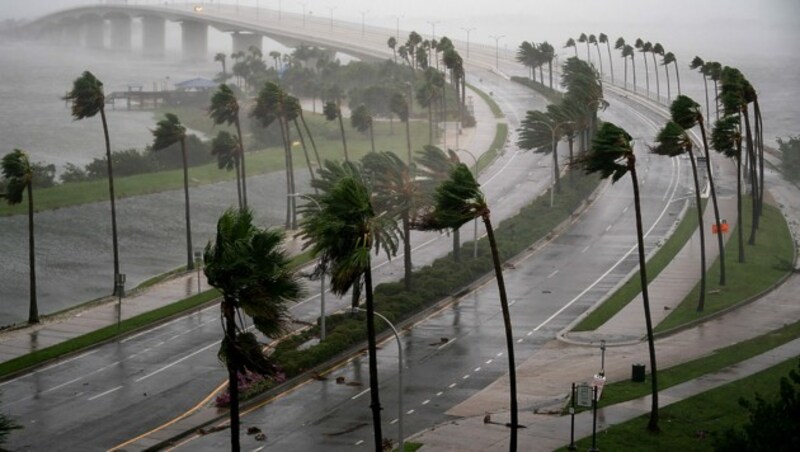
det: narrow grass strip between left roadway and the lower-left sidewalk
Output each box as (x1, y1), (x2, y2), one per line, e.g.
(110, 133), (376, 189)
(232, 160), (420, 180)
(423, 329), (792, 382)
(0, 289), (219, 378)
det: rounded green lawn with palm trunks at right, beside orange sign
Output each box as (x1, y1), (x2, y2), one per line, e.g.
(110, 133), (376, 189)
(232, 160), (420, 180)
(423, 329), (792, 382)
(655, 199), (794, 332)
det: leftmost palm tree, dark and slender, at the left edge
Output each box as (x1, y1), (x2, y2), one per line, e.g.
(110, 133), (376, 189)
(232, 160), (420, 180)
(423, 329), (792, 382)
(0, 149), (39, 323)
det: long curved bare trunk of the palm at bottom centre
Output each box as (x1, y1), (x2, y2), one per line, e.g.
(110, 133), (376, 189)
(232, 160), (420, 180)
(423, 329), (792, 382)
(481, 214), (519, 452)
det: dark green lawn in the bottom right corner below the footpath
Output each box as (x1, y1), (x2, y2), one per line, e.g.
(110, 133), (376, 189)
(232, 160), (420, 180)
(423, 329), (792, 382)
(558, 359), (797, 452)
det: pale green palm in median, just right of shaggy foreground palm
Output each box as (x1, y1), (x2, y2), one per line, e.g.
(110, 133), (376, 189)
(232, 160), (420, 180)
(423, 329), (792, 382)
(362, 151), (426, 291)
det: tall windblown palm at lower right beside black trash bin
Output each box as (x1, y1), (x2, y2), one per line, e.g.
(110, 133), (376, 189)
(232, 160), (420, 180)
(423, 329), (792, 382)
(582, 122), (659, 431)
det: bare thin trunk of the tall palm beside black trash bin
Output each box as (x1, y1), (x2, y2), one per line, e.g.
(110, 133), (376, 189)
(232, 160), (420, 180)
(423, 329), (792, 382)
(628, 161), (659, 432)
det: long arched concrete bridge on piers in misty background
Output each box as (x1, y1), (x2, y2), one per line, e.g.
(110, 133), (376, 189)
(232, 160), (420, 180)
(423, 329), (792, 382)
(23, 0), (412, 60)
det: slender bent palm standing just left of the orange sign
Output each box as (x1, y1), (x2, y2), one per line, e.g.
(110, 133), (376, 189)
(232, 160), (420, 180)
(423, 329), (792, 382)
(650, 120), (708, 312)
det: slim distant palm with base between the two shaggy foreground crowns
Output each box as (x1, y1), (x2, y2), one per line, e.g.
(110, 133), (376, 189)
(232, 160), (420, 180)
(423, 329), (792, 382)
(250, 82), (296, 229)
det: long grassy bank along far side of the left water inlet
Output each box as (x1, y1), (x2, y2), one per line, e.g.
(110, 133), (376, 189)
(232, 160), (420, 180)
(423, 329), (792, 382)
(0, 115), (428, 216)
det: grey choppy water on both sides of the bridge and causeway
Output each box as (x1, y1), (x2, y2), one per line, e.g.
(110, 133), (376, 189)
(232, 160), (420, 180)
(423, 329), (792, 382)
(0, 5), (800, 326)
